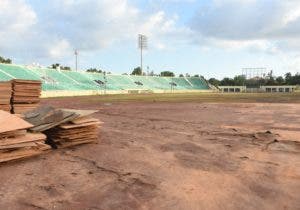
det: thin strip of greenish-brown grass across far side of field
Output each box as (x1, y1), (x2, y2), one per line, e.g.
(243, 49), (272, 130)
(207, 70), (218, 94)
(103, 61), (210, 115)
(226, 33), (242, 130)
(47, 92), (300, 103)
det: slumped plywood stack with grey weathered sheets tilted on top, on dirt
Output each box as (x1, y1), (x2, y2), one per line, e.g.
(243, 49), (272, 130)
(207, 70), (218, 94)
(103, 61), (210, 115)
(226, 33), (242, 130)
(24, 106), (102, 148)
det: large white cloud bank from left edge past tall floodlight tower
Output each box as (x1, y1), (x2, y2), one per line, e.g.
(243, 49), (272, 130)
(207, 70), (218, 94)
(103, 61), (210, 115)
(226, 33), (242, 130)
(0, 0), (188, 59)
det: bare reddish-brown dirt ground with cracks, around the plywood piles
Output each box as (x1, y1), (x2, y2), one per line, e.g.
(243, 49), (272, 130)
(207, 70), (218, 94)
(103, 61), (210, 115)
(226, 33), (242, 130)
(0, 98), (300, 210)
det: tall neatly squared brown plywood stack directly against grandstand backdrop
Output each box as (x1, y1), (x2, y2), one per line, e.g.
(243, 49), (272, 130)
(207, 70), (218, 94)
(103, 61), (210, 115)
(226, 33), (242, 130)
(11, 79), (41, 114)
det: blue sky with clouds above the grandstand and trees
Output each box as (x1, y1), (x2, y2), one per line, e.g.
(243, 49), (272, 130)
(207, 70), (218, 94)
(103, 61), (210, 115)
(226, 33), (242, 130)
(0, 0), (300, 78)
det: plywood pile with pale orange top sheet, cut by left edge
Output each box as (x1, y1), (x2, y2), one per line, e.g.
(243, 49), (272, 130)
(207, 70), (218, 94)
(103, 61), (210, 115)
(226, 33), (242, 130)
(0, 110), (50, 162)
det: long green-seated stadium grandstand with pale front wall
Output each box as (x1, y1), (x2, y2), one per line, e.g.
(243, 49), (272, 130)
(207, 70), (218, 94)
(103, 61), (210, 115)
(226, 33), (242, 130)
(0, 64), (211, 97)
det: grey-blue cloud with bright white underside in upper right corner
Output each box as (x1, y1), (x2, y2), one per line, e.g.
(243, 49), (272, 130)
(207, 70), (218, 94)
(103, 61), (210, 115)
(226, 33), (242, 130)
(191, 0), (300, 53)
